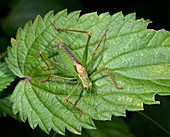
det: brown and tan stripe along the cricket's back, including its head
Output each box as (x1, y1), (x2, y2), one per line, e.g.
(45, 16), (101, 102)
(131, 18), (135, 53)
(58, 42), (92, 89)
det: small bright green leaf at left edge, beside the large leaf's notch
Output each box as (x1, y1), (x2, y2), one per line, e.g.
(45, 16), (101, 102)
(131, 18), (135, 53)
(0, 62), (15, 93)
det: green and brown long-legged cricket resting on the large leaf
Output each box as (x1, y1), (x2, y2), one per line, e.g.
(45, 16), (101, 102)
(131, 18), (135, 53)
(38, 22), (123, 117)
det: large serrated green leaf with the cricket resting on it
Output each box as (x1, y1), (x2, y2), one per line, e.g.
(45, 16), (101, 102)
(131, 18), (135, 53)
(7, 10), (170, 134)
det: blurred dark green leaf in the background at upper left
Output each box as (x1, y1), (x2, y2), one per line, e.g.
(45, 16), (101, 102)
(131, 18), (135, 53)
(5, 0), (82, 30)
